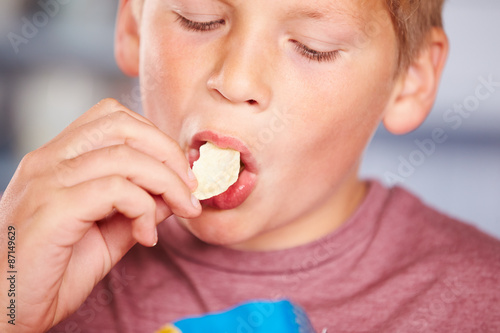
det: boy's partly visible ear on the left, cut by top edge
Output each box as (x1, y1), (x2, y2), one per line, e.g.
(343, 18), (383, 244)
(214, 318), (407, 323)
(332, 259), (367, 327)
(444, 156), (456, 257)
(115, 0), (140, 77)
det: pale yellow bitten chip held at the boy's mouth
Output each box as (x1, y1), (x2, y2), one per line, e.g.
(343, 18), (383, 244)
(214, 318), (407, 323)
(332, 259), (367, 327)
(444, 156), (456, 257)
(193, 142), (240, 200)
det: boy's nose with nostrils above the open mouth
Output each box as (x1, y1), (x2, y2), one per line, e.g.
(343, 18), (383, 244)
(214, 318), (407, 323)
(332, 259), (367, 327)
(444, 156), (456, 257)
(207, 27), (272, 111)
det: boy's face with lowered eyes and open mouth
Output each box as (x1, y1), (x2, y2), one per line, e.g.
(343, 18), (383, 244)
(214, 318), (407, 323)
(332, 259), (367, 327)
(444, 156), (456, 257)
(133, 0), (397, 248)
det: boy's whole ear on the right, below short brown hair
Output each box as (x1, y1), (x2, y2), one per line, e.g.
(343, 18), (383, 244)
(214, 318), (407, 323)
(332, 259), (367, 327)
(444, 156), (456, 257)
(383, 28), (449, 134)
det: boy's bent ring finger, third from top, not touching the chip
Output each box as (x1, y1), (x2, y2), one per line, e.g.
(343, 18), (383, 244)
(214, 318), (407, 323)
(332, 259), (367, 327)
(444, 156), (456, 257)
(31, 175), (157, 247)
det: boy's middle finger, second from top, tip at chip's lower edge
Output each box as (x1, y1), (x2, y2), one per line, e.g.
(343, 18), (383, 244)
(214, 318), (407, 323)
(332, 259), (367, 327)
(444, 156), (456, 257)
(56, 145), (200, 218)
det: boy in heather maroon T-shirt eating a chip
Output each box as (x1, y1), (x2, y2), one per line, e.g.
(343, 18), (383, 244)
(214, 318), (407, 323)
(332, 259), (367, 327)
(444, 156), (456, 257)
(0, 0), (500, 332)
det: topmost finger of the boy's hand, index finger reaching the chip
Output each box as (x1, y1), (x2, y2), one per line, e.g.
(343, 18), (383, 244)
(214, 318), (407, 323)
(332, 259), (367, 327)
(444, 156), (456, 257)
(53, 111), (197, 190)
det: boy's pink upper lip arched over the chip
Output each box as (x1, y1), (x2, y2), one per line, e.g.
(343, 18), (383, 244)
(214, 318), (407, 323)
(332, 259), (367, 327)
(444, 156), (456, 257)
(189, 131), (257, 173)
